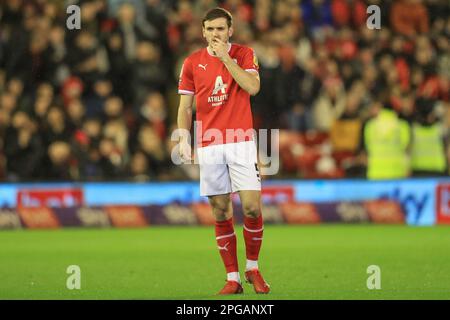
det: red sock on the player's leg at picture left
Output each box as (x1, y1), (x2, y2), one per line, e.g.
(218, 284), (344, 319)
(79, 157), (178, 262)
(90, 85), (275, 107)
(216, 218), (238, 273)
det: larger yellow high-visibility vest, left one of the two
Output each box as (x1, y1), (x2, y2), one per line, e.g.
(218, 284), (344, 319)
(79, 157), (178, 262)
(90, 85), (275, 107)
(364, 109), (410, 179)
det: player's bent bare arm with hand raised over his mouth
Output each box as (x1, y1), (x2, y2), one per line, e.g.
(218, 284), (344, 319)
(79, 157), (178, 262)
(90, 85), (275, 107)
(213, 40), (260, 96)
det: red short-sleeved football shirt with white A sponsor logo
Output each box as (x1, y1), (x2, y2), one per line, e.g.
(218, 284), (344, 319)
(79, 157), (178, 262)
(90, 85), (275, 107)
(178, 43), (259, 147)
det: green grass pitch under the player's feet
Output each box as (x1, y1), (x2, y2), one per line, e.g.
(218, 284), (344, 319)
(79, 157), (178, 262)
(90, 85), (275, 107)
(0, 225), (450, 300)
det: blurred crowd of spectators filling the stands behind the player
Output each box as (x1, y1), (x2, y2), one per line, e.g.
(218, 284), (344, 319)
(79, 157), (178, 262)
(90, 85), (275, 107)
(0, 0), (450, 181)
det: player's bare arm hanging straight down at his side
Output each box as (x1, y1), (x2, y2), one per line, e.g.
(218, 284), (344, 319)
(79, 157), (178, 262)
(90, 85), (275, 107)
(177, 94), (194, 161)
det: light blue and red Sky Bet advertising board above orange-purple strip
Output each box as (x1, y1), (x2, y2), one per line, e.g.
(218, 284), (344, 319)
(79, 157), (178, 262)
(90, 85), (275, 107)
(0, 178), (450, 226)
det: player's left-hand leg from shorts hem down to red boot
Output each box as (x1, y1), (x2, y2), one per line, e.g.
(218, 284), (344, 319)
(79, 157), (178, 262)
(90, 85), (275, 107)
(208, 194), (242, 294)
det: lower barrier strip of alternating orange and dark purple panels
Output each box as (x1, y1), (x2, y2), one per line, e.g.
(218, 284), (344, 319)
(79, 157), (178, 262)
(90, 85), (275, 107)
(0, 200), (405, 229)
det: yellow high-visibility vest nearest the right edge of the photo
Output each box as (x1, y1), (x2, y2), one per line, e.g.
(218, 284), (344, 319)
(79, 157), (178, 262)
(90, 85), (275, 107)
(411, 124), (446, 173)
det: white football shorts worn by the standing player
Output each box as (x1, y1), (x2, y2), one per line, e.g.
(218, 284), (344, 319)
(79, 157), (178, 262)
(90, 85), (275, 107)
(197, 141), (261, 196)
